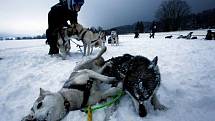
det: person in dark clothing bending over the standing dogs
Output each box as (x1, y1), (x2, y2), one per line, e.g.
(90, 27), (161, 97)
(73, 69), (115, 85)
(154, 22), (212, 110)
(46, 0), (84, 55)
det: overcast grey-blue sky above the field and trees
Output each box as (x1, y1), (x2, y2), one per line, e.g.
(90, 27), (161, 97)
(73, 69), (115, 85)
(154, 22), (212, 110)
(0, 0), (215, 35)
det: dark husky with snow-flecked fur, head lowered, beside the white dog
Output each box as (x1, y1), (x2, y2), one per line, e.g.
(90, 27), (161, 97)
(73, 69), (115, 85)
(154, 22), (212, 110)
(103, 54), (167, 117)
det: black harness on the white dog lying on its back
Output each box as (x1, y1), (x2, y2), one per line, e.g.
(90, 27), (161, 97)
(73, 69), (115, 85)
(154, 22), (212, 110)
(63, 80), (93, 108)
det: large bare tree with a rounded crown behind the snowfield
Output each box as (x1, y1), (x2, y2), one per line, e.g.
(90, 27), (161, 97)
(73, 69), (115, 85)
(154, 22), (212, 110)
(155, 0), (190, 31)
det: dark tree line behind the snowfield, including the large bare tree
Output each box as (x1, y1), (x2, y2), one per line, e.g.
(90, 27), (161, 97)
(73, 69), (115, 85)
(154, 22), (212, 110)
(106, 0), (215, 34)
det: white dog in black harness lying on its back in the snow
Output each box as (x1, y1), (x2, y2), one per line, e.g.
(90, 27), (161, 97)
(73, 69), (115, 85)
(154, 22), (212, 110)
(22, 47), (122, 121)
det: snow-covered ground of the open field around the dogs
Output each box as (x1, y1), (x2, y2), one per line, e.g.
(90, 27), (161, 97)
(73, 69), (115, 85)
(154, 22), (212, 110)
(0, 30), (215, 121)
